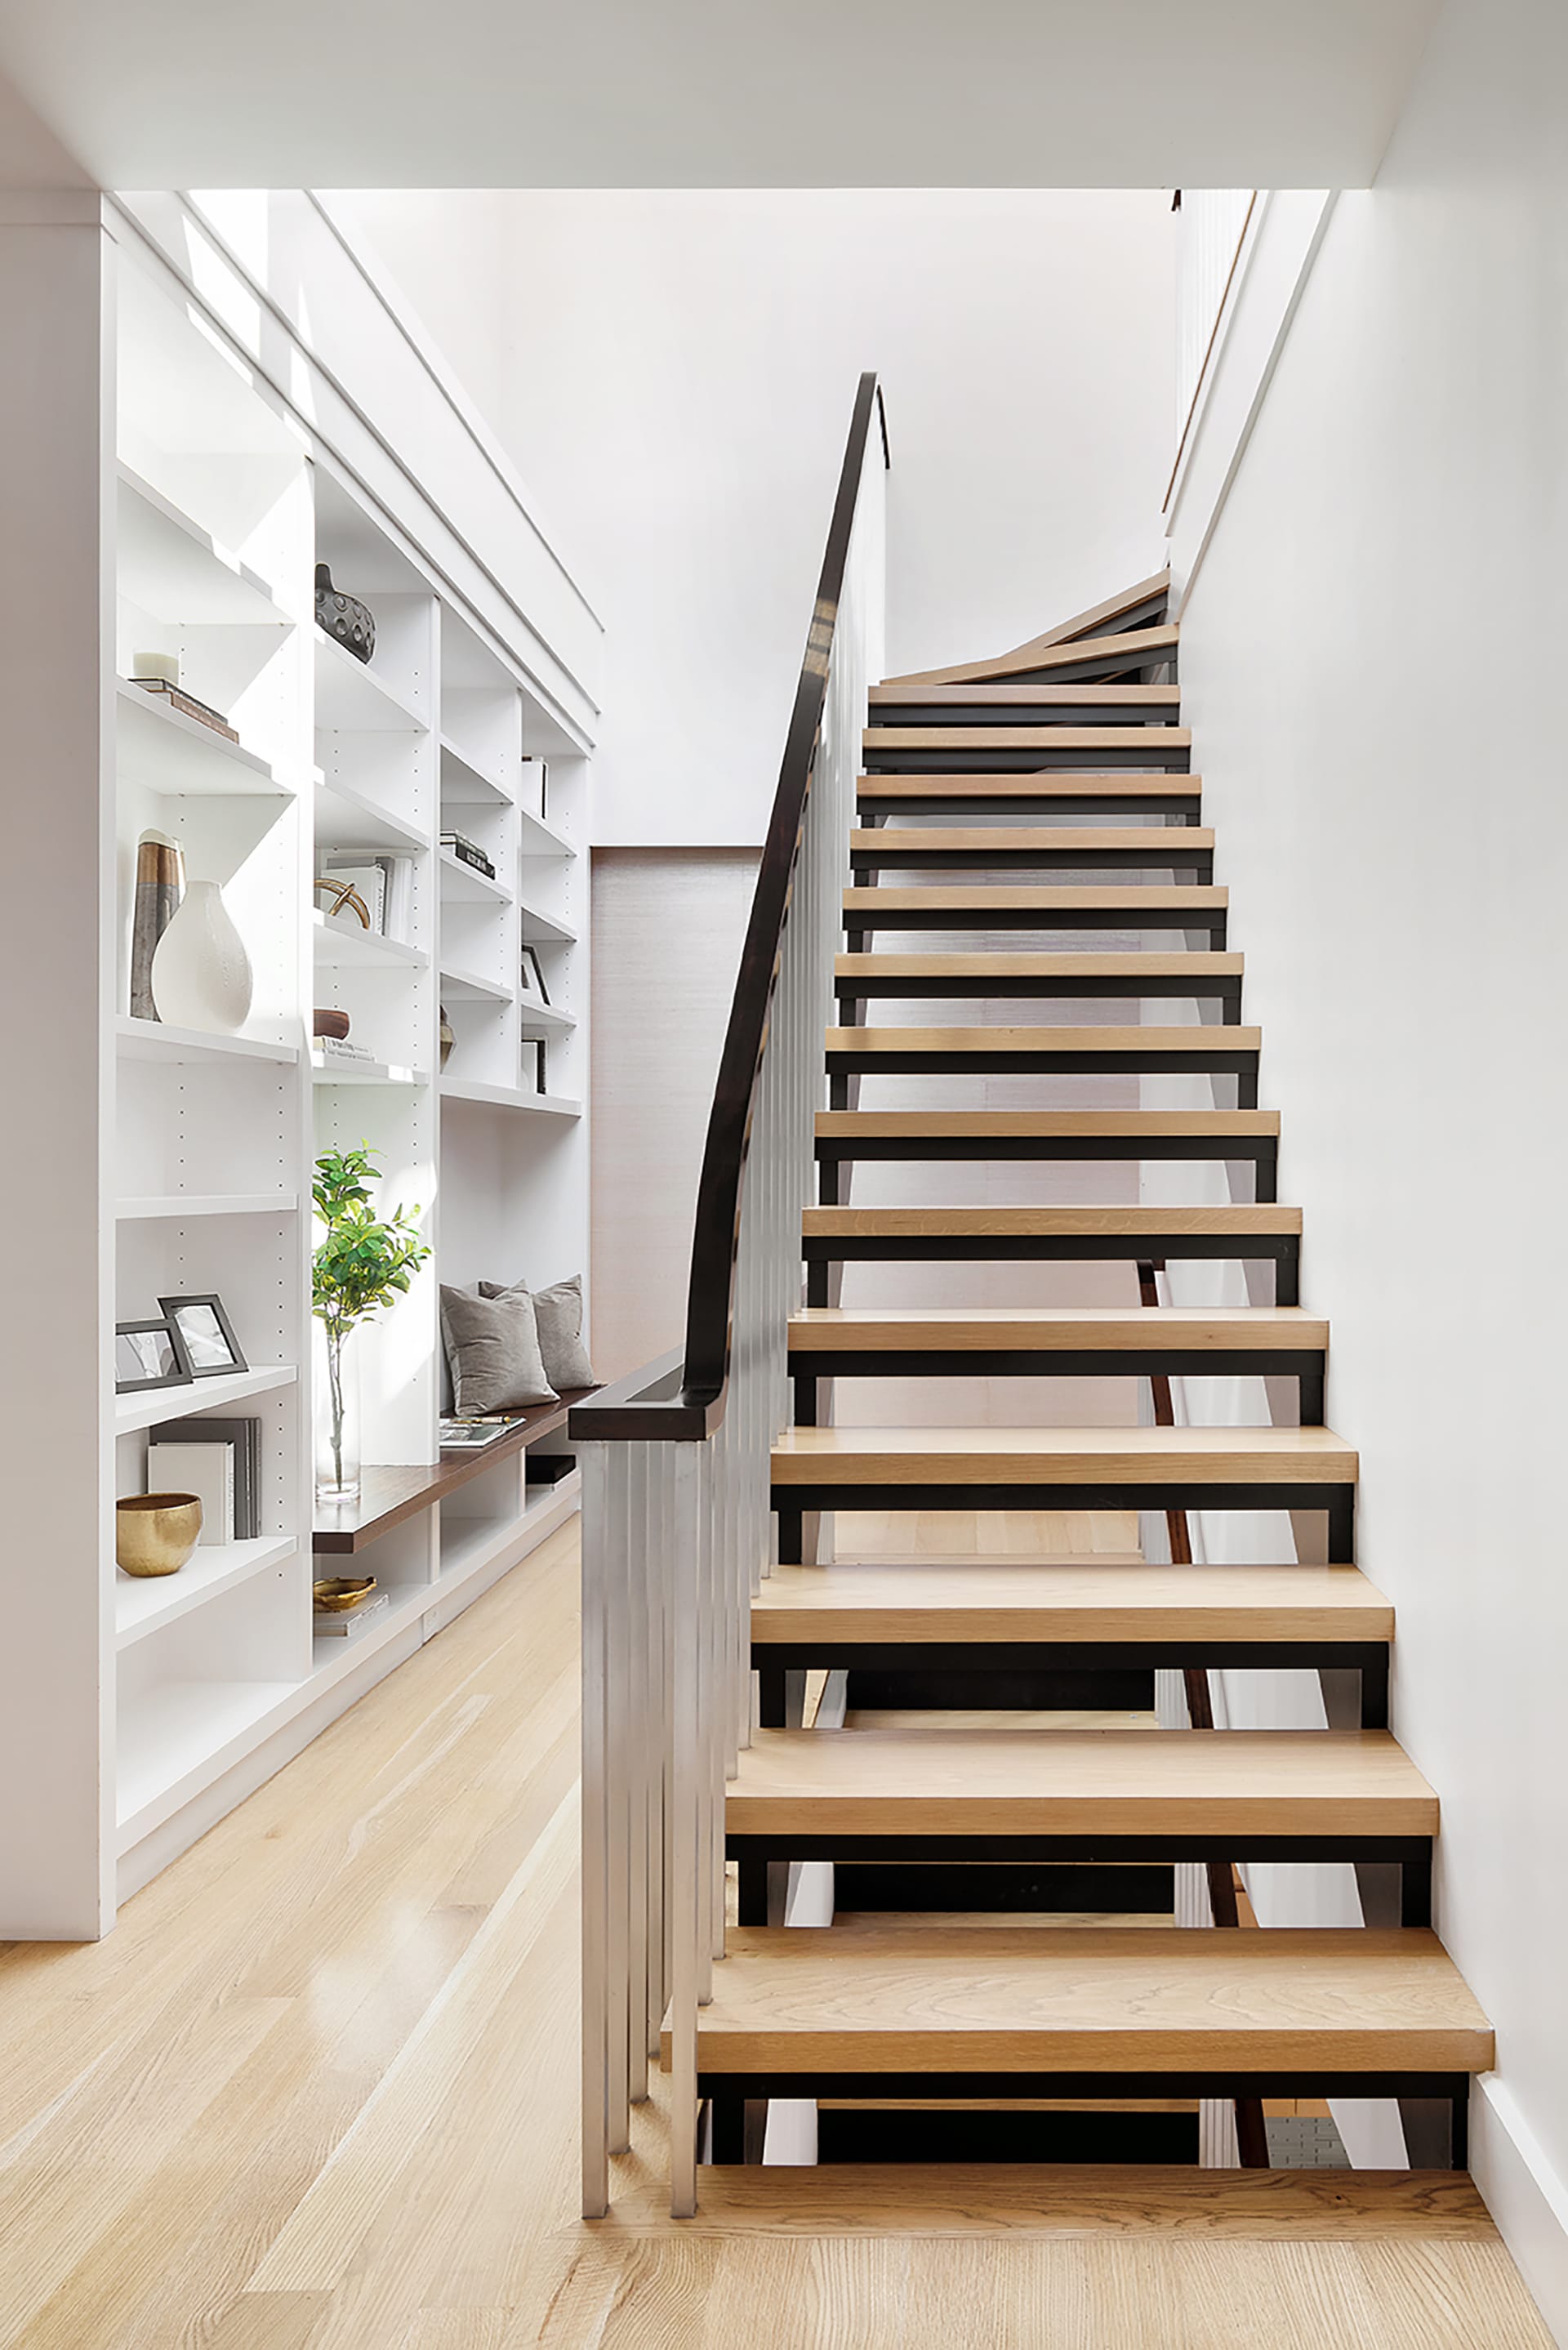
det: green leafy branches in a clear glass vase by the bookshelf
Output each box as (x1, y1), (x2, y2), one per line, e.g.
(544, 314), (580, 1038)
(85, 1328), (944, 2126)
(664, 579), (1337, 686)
(310, 1142), (430, 1501)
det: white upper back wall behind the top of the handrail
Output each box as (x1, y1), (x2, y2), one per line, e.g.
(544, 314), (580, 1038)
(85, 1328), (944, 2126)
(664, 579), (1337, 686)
(355, 188), (1173, 846)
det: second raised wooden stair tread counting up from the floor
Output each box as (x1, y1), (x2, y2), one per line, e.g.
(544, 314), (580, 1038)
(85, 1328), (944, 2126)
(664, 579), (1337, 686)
(724, 1725), (1437, 1838)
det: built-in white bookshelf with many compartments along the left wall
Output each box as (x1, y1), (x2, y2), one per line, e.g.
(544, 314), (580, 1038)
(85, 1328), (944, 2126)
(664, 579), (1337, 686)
(0, 195), (597, 1939)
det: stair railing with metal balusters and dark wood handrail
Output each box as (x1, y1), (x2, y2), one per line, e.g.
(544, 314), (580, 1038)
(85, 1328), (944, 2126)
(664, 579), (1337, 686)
(569, 373), (889, 2218)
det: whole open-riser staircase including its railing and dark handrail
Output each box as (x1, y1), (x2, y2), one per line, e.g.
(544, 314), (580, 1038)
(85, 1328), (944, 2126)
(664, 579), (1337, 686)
(571, 378), (1493, 2214)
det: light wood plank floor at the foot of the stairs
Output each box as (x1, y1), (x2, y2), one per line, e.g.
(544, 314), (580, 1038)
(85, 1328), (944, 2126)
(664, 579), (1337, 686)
(0, 1527), (1549, 2350)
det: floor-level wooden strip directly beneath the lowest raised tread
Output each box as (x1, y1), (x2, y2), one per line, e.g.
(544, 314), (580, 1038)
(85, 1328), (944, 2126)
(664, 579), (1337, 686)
(595, 2162), (1500, 2236)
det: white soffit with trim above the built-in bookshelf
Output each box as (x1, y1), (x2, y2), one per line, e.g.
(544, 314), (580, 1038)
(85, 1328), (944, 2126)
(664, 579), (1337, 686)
(118, 190), (604, 745)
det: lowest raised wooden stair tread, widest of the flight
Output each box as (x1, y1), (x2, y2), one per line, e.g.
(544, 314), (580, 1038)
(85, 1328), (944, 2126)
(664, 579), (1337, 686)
(677, 1927), (1493, 2075)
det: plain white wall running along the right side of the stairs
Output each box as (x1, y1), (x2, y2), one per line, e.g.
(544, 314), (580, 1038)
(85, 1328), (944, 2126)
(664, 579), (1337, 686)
(1183, 0), (1568, 2339)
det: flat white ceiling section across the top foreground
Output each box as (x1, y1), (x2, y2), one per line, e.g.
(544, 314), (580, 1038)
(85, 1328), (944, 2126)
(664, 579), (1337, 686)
(0, 0), (1434, 188)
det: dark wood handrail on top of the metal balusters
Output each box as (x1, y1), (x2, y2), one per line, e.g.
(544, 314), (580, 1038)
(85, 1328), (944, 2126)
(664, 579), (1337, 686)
(569, 373), (891, 1441)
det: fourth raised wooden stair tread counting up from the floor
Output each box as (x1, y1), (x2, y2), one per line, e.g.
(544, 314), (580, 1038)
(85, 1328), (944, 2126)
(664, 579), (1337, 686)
(773, 1426), (1356, 1487)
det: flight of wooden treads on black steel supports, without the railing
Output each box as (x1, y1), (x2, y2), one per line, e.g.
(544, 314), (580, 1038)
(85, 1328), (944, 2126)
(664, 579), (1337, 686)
(698, 581), (1490, 2165)
